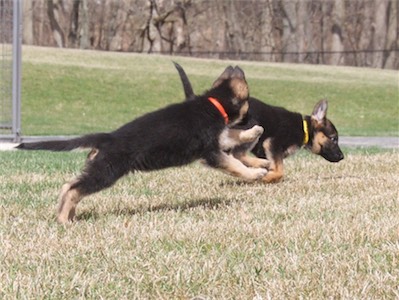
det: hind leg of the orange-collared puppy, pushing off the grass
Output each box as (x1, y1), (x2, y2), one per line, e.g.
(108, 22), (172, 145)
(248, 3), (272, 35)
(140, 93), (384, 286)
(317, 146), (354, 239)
(57, 152), (128, 224)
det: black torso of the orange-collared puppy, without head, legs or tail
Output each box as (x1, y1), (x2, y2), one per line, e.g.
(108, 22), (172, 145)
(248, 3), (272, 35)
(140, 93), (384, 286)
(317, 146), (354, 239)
(112, 99), (225, 170)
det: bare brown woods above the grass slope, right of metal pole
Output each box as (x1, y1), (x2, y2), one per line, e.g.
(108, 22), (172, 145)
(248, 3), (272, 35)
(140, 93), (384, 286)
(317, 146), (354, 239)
(23, 0), (399, 69)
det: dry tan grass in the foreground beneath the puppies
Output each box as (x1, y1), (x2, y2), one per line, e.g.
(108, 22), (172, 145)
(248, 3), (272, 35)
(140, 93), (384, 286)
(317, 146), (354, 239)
(0, 151), (399, 299)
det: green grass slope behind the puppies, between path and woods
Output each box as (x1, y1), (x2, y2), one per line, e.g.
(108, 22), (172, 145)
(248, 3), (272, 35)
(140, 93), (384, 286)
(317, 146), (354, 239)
(22, 46), (399, 136)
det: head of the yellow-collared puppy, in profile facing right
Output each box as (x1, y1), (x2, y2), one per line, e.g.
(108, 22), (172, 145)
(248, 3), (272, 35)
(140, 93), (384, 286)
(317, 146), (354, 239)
(306, 100), (344, 162)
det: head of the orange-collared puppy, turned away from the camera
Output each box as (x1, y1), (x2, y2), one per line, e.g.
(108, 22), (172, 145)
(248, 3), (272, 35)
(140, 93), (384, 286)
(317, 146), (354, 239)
(205, 66), (249, 126)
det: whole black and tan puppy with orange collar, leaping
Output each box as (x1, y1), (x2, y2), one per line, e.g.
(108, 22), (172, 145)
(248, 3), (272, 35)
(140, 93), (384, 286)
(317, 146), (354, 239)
(17, 67), (267, 223)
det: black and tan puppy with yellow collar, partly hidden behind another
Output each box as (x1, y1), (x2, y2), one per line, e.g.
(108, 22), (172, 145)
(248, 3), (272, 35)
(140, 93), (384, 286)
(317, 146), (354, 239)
(175, 63), (344, 182)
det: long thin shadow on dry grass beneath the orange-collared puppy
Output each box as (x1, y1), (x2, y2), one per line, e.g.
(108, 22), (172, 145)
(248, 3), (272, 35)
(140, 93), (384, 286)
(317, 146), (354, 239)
(76, 198), (234, 221)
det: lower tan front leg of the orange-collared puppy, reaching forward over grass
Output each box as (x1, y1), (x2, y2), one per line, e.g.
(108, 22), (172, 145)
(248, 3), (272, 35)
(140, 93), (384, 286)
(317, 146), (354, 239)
(211, 152), (267, 181)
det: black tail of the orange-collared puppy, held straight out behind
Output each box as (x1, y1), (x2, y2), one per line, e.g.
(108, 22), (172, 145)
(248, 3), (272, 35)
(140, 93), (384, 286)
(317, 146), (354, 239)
(16, 133), (112, 151)
